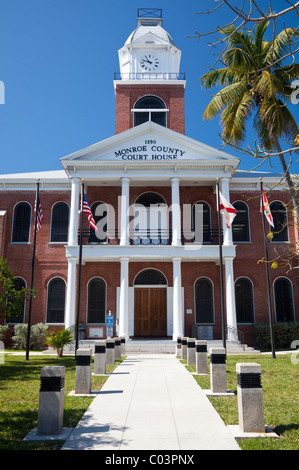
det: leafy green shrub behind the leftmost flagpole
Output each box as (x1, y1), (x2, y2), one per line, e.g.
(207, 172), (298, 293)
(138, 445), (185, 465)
(12, 323), (48, 350)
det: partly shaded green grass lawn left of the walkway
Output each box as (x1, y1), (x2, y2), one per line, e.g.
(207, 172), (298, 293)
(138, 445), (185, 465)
(0, 354), (121, 450)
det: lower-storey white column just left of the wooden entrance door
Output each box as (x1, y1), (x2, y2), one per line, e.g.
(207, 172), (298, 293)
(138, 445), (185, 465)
(118, 258), (129, 339)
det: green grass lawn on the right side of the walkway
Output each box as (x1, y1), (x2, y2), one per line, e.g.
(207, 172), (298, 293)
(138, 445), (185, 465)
(182, 354), (299, 450)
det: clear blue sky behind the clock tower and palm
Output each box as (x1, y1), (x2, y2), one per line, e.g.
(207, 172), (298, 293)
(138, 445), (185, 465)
(0, 0), (299, 174)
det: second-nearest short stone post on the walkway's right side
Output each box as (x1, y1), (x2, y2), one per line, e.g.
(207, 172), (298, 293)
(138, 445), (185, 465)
(210, 348), (227, 393)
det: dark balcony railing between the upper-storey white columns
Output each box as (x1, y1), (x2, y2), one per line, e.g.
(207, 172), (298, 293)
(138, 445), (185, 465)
(78, 229), (223, 246)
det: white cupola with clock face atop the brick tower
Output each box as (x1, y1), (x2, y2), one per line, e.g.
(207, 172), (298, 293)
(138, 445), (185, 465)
(118, 8), (182, 80)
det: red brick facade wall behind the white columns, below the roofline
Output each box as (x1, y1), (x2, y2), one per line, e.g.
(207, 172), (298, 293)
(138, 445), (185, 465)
(0, 185), (299, 344)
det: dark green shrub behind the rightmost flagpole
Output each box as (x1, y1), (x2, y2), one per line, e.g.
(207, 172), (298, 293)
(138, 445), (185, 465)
(254, 323), (299, 350)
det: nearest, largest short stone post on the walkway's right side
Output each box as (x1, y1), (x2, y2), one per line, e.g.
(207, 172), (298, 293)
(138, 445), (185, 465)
(236, 363), (265, 433)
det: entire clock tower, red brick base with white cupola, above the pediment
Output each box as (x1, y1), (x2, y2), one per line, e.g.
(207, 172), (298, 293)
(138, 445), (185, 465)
(114, 8), (186, 134)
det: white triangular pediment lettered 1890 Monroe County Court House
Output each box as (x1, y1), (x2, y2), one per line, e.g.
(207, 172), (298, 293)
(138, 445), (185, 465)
(61, 122), (239, 167)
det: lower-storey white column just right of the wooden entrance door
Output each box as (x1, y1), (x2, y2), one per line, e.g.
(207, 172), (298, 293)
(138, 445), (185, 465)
(172, 258), (184, 341)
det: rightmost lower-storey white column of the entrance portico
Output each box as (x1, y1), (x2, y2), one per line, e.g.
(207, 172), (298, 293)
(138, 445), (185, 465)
(224, 257), (238, 341)
